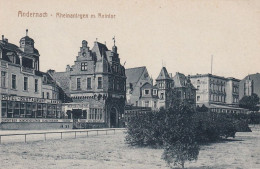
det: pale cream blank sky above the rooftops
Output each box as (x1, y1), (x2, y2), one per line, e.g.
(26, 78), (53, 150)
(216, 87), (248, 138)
(0, 0), (260, 79)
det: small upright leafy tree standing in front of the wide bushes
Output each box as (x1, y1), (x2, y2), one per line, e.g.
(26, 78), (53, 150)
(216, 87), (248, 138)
(162, 103), (199, 168)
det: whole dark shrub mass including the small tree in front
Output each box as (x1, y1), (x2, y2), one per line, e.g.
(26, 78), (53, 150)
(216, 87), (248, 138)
(126, 104), (249, 167)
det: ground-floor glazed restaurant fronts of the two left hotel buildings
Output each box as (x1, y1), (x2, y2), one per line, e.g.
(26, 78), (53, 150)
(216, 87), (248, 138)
(0, 95), (124, 129)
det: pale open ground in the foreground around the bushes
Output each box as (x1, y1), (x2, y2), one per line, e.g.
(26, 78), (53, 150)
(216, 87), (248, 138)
(0, 126), (260, 169)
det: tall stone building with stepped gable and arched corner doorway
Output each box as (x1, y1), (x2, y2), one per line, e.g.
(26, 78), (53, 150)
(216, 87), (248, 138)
(51, 40), (126, 127)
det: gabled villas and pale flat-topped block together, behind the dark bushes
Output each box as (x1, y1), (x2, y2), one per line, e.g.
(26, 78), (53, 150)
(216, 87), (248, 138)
(126, 67), (247, 113)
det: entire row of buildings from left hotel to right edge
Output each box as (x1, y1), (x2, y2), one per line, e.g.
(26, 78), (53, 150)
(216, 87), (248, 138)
(0, 30), (260, 129)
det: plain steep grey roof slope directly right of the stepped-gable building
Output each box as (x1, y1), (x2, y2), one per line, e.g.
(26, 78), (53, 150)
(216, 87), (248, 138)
(125, 66), (146, 84)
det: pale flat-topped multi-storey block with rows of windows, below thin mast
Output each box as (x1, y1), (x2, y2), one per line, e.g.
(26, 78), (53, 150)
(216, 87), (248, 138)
(190, 74), (246, 112)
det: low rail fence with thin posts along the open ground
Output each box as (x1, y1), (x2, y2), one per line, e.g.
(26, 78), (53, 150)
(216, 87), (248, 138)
(0, 128), (125, 144)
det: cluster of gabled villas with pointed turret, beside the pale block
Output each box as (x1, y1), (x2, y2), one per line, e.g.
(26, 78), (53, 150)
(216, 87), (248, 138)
(126, 67), (196, 111)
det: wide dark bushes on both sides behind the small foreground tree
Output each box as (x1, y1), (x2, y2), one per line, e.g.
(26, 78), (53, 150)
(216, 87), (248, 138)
(126, 109), (251, 146)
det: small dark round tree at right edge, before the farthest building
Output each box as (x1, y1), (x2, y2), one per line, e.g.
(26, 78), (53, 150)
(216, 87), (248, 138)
(239, 93), (259, 111)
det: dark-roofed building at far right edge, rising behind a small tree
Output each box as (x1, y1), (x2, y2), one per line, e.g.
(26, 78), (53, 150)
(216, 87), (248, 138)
(239, 73), (260, 99)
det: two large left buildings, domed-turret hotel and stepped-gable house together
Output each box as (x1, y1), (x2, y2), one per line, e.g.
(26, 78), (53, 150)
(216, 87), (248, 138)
(0, 30), (126, 129)
